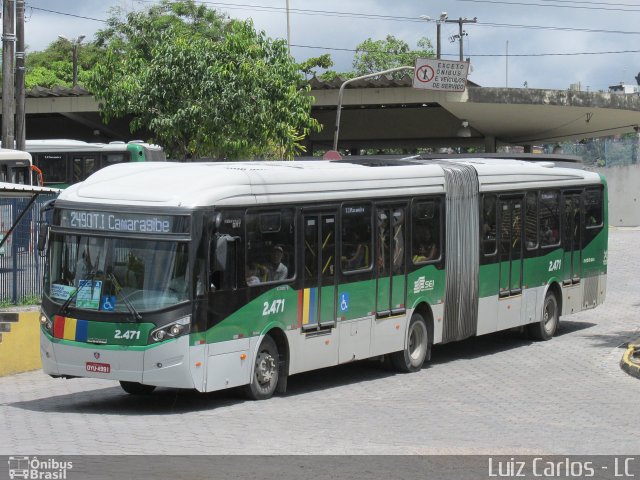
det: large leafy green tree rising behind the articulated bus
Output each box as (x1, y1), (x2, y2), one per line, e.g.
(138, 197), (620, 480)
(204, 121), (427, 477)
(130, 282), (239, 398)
(88, 0), (319, 159)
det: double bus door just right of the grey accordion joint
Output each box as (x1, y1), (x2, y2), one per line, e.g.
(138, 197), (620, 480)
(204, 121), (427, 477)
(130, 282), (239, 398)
(498, 197), (524, 297)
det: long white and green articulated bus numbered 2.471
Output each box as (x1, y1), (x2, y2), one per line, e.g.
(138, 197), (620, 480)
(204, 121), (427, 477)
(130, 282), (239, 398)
(40, 158), (607, 399)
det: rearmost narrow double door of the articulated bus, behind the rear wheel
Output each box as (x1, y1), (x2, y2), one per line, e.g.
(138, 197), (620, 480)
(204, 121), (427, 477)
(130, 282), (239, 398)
(562, 193), (582, 284)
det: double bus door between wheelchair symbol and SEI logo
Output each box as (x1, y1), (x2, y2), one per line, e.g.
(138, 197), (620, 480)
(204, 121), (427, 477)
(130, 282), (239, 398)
(375, 206), (406, 317)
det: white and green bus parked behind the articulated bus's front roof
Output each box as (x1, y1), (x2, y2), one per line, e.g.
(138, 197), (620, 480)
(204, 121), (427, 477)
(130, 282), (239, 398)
(25, 140), (166, 188)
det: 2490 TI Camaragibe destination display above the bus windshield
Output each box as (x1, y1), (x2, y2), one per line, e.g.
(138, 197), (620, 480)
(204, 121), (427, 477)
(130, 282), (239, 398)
(60, 209), (189, 235)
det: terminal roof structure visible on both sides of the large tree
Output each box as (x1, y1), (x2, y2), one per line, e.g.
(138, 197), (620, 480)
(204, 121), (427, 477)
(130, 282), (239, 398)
(5, 80), (640, 151)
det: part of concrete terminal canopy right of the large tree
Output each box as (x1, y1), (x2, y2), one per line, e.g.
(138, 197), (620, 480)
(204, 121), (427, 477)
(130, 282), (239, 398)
(309, 76), (640, 152)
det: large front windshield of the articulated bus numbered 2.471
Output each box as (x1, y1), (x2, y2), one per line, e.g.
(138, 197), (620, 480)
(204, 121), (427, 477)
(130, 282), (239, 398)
(45, 233), (190, 312)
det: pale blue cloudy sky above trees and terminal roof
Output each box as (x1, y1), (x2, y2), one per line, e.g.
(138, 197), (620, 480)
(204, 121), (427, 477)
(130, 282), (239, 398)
(25, 0), (640, 91)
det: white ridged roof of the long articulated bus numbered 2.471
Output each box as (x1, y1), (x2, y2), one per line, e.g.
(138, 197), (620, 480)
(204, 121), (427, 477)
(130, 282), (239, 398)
(60, 158), (601, 208)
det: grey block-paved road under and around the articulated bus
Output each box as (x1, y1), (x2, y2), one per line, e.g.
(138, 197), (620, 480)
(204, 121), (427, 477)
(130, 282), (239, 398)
(0, 229), (640, 455)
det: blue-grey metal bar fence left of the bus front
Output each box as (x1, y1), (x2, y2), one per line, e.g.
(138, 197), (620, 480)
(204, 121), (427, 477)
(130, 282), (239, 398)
(0, 195), (55, 305)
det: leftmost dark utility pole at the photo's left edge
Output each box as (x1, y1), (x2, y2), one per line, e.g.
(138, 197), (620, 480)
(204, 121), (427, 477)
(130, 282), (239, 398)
(2, 0), (16, 148)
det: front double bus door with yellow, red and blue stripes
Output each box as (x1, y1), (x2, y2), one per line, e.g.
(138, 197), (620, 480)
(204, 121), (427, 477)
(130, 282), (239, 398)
(301, 213), (336, 330)
